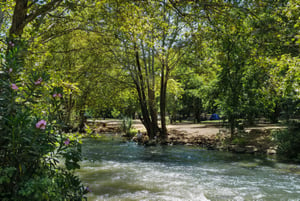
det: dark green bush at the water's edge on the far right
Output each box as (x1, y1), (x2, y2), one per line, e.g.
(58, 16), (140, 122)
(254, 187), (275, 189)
(274, 121), (300, 162)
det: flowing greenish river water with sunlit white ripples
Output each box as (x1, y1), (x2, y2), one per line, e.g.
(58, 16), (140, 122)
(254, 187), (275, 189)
(78, 138), (300, 201)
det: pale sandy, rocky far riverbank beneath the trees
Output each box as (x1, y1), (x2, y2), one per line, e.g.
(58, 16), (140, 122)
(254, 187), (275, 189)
(85, 120), (283, 154)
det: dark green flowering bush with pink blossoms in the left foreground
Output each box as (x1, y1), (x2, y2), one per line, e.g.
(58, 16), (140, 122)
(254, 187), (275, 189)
(0, 38), (89, 201)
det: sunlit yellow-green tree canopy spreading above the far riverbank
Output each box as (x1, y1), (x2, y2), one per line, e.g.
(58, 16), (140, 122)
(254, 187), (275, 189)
(1, 0), (300, 139)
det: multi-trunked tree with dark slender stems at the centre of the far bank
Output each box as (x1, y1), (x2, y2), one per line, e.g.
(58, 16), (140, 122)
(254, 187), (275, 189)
(97, 1), (190, 142)
